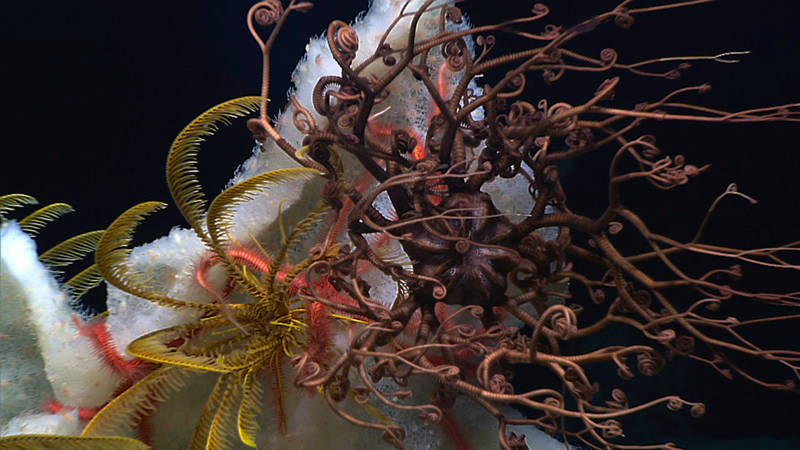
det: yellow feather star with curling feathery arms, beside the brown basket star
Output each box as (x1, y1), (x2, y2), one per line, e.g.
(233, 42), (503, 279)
(83, 97), (337, 448)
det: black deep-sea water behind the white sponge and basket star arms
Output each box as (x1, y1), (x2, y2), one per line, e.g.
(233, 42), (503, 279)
(0, 0), (800, 449)
